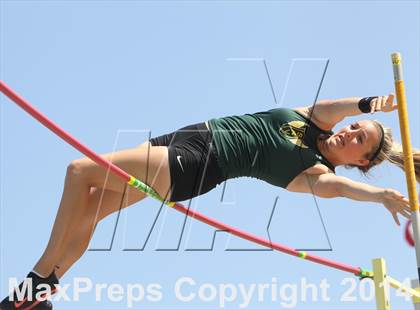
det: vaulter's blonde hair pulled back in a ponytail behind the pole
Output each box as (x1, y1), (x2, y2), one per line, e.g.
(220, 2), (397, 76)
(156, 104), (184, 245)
(346, 121), (420, 183)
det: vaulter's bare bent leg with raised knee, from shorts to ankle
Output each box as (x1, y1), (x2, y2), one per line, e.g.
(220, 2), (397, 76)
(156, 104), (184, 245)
(34, 142), (171, 275)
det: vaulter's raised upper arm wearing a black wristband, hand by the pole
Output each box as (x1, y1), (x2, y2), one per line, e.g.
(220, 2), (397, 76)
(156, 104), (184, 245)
(297, 93), (397, 130)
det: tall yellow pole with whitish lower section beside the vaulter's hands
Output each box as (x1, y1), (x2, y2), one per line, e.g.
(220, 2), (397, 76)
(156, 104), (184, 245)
(391, 53), (420, 279)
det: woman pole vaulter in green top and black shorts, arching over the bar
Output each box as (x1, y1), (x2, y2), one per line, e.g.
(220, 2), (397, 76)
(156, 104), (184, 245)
(0, 94), (420, 310)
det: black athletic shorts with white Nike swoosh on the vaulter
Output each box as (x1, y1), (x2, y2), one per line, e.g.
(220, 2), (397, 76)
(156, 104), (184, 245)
(150, 123), (225, 202)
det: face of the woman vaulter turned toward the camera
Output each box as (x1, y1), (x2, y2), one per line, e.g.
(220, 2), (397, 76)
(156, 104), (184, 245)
(326, 120), (381, 166)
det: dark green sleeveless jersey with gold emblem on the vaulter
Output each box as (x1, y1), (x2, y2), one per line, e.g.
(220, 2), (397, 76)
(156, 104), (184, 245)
(208, 108), (334, 188)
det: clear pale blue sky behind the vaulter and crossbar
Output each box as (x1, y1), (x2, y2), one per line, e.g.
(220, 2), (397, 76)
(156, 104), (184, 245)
(0, 0), (420, 309)
